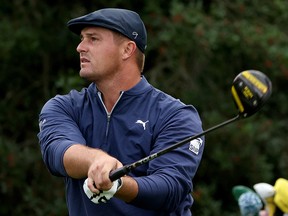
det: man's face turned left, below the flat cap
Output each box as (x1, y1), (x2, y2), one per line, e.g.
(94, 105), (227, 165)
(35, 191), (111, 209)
(77, 27), (121, 82)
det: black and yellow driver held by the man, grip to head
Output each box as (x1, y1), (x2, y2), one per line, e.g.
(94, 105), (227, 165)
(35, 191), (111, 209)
(109, 70), (272, 181)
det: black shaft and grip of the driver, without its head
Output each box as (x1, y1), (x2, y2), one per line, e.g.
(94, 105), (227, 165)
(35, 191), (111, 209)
(109, 115), (240, 181)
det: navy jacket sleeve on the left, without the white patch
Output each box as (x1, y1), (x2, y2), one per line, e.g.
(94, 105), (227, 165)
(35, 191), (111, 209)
(38, 96), (86, 176)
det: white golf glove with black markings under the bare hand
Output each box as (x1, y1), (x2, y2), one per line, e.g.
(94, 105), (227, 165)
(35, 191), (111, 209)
(83, 179), (122, 204)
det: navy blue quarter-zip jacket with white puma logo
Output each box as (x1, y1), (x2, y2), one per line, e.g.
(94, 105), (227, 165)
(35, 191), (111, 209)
(38, 77), (204, 216)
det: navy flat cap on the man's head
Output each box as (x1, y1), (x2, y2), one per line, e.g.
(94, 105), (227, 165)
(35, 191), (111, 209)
(67, 8), (147, 53)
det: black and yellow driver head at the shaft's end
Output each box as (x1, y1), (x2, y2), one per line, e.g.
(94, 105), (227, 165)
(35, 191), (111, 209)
(231, 70), (272, 118)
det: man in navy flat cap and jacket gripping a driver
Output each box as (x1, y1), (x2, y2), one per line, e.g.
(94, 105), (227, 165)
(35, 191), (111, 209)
(38, 8), (204, 216)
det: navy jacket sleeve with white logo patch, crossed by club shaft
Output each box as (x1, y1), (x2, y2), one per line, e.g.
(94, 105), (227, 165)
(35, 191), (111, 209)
(131, 106), (204, 212)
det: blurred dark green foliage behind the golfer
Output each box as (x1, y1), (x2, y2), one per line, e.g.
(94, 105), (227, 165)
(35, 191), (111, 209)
(0, 0), (288, 216)
